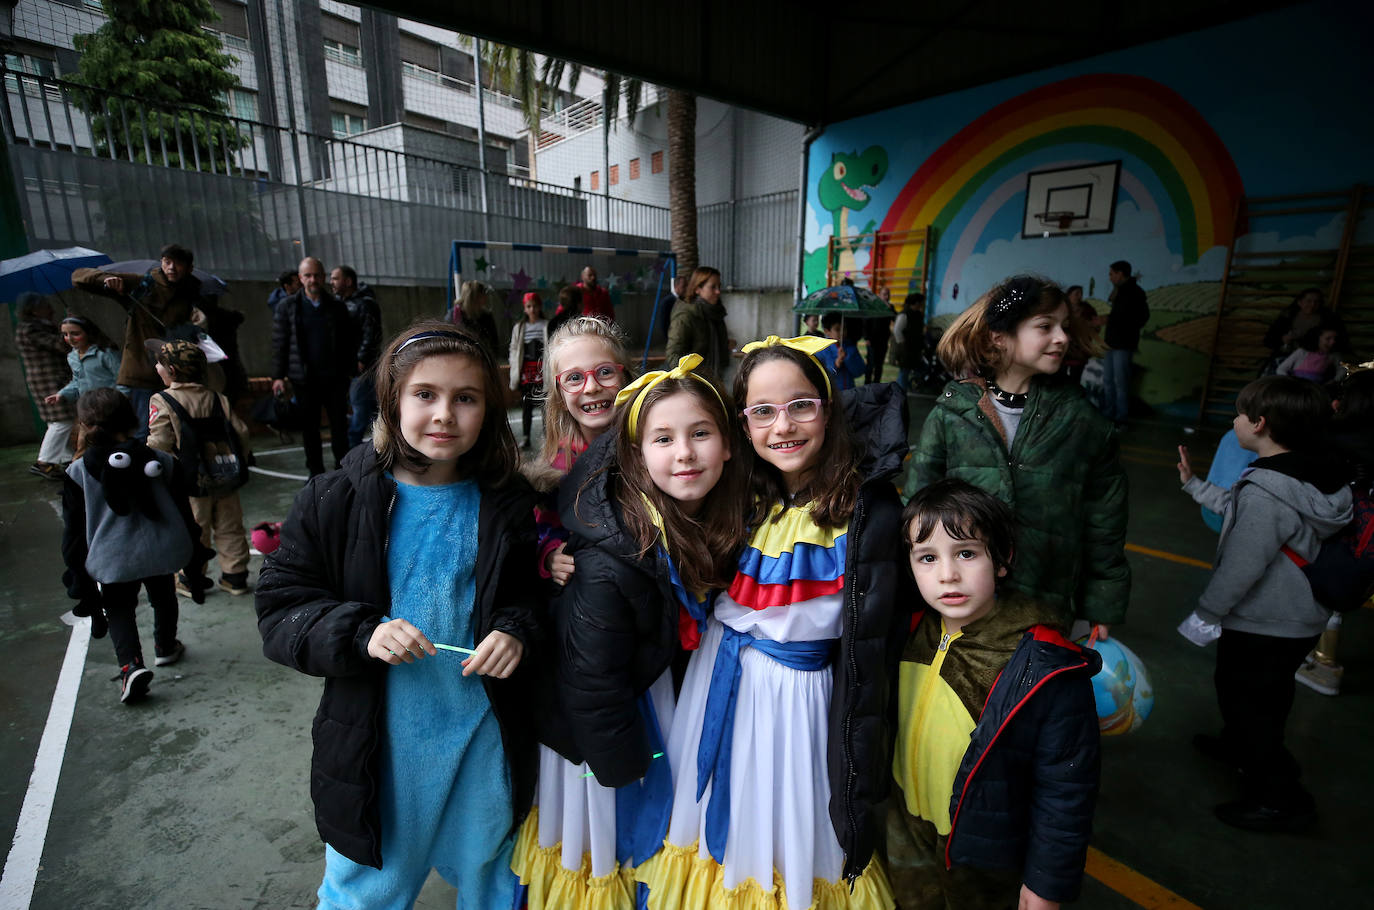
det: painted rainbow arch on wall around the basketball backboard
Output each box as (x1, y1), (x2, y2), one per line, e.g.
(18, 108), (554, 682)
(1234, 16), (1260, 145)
(878, 73), (1243, 308)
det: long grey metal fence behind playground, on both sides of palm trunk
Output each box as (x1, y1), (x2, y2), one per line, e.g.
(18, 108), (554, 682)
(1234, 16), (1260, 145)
(0, 67), (797, 289)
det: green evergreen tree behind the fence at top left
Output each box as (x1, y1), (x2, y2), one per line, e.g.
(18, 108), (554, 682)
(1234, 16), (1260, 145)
(73, 0), (247, 172)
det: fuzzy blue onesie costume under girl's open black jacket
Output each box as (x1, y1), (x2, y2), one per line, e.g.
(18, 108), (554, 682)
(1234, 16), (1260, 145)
(319, 481), (519, 910)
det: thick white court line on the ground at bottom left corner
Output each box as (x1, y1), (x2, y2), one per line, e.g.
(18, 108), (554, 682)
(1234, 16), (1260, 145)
(0, 619), (91, 910)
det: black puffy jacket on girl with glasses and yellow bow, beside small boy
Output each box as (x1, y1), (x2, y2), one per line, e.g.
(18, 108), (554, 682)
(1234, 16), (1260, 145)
(826, 382), (918, 880)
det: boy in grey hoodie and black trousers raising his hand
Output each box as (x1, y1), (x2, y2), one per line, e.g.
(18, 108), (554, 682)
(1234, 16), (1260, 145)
(1179, 375), (1353, 832)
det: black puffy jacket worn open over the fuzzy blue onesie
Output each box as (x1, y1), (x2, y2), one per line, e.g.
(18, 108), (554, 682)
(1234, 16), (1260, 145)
(257, 447), (544, 869)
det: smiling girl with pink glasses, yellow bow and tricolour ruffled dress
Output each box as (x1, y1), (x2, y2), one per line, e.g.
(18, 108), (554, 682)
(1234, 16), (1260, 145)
(636, 337), (915, 910)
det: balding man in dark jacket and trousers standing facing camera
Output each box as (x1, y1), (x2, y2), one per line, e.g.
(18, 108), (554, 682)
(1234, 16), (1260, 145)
(272, 257), (357, 477)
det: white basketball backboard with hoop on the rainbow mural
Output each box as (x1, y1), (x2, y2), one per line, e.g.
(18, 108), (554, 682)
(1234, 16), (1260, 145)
(1021, 161), (1121, 238)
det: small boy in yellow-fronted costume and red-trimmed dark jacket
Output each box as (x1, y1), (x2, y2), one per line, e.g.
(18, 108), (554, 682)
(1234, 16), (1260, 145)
(888, 480), (1102, 910)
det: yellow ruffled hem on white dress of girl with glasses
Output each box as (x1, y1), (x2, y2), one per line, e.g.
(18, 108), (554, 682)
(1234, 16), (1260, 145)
(629, 843), (896, 910)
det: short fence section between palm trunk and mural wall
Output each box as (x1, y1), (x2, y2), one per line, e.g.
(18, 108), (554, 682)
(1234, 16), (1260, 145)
(697, 190), (797, 290)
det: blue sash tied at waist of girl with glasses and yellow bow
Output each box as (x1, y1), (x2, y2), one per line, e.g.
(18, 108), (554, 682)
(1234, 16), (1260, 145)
(697, 625), (835, 863)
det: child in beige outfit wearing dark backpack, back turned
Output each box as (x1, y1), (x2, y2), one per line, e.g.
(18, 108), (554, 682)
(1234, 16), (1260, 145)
(148, 341), (249, 597)
